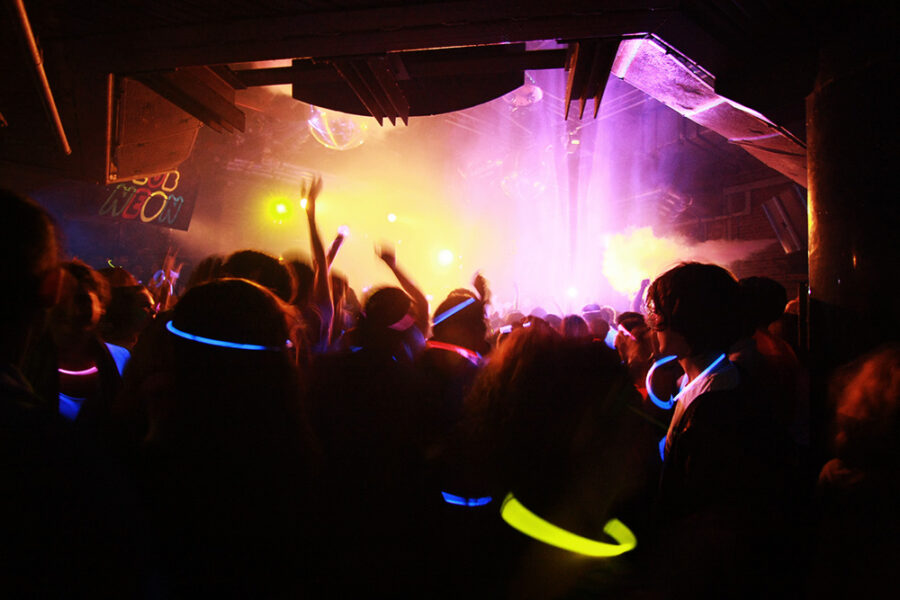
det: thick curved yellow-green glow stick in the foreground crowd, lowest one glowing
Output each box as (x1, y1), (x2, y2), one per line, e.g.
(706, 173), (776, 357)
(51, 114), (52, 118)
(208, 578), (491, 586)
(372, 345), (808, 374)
(500, 492), (637, 556)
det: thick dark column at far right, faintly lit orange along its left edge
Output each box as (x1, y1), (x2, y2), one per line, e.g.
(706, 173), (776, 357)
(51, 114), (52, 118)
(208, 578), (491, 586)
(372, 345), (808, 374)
(806, 2), (900, 458)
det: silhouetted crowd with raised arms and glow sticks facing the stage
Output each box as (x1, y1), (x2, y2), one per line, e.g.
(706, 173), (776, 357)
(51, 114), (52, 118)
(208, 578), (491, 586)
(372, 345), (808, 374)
(0, 185), (900, 599)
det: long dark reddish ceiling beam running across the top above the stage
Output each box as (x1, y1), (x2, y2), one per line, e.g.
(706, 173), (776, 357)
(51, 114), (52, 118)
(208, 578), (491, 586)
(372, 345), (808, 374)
(61, 0), (679, 74)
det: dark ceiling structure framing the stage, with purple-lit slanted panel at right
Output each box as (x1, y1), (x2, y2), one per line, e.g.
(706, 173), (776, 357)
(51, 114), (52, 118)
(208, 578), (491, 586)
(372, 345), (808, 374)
(0, 0), (817, 184)
